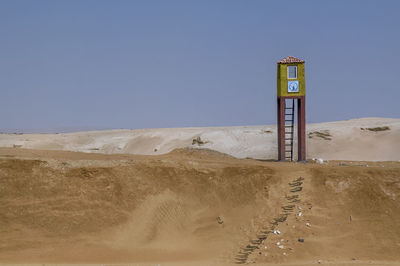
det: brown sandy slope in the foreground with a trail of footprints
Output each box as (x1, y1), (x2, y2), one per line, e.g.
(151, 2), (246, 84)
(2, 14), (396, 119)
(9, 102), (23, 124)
(0, 148), (400, 265)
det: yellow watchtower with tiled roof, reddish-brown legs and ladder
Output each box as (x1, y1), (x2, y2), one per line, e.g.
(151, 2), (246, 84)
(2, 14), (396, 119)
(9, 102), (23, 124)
(277, 56), (306, 161)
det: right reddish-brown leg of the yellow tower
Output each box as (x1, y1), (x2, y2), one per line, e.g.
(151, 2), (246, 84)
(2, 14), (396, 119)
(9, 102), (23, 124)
(297, 96), (306, 161)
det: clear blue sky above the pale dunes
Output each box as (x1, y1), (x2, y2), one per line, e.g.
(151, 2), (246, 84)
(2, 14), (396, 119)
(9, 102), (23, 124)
(0, 0), (400, 129)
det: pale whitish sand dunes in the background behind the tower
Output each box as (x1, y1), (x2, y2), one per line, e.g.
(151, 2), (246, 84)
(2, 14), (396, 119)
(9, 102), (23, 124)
(0, 118), (400, 161)
